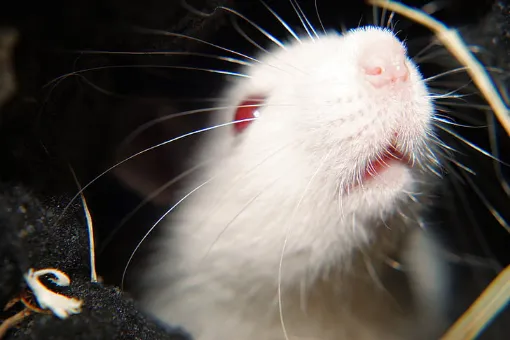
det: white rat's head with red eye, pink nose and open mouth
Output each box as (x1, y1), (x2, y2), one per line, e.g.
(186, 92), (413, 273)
(203, 27), (433, 244)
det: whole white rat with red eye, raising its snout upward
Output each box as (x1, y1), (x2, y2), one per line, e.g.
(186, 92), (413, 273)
(138, 27), (446, 340)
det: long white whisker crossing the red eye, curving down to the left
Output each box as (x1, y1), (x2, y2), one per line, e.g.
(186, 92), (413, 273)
(54, 118), (258, 231)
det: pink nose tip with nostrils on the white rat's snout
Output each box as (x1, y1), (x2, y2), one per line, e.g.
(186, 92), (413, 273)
(361, 54), (409, 88)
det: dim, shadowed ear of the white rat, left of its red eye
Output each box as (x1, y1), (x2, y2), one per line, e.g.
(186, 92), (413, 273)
(113, 99), (207, 206)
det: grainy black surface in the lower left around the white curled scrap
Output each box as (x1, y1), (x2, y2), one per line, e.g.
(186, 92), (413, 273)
(0, 186), (188, 340)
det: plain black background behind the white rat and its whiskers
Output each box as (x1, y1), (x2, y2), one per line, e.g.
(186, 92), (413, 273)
(0, 0), (510, 338)
